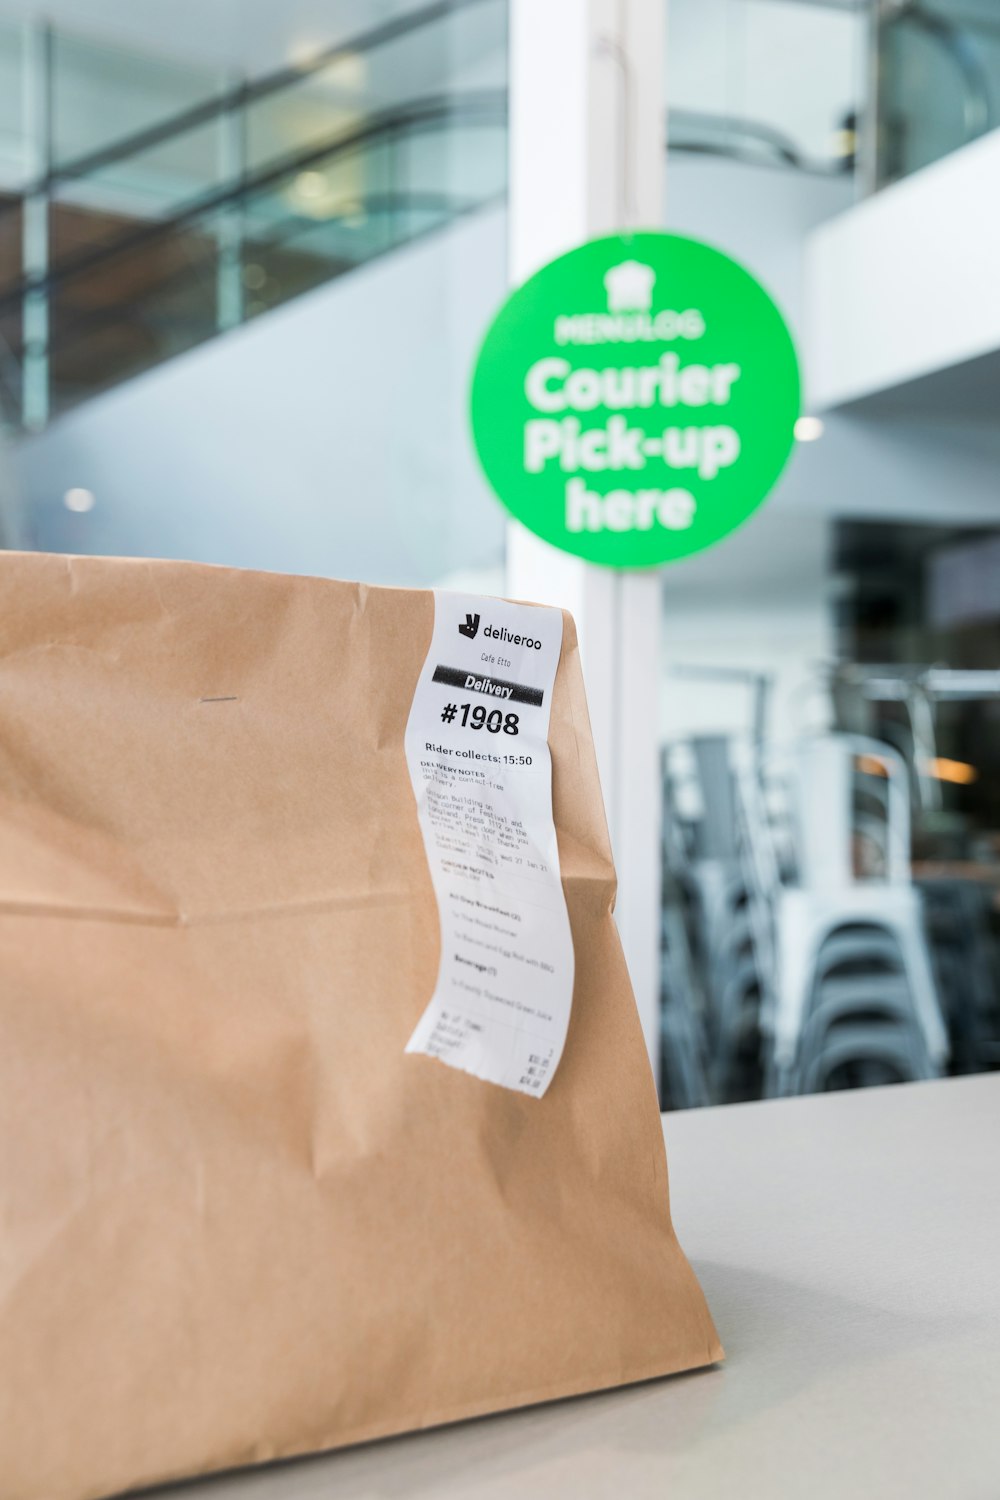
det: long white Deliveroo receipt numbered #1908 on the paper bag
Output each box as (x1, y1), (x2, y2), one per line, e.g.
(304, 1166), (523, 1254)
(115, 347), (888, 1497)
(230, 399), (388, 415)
(406, 591), (574, 1098)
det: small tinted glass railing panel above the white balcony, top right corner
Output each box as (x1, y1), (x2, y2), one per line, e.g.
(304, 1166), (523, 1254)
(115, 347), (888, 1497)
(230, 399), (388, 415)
(870, 0), (1000, 188)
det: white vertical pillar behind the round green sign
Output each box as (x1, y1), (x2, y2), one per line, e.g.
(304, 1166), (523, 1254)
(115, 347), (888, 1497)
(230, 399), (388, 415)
(507, 0), (666, 1080)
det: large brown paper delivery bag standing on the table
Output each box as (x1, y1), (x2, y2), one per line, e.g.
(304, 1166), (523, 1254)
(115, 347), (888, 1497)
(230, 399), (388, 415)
(0, 554), (721, 1500)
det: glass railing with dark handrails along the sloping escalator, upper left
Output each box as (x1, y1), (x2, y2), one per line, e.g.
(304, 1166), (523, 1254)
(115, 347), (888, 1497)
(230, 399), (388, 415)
(0, 0), (507, 429)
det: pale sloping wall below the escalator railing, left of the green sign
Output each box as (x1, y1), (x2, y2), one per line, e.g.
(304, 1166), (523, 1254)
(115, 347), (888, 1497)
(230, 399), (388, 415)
(15, 212), (505, 587)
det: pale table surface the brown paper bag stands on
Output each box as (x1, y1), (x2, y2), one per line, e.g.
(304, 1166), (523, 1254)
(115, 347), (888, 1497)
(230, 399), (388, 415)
(150, 1076), (1000, 1500)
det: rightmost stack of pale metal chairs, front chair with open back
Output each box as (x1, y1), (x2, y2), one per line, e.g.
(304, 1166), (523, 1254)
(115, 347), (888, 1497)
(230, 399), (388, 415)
(768, 735), (948, 1094)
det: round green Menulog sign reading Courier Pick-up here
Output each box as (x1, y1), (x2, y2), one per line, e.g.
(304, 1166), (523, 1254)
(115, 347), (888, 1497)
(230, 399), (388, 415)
(472, 233), (799, 567)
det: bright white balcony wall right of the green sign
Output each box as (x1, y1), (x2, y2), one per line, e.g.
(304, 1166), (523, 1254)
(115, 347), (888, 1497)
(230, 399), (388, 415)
(807, 131), (1000, 408)
